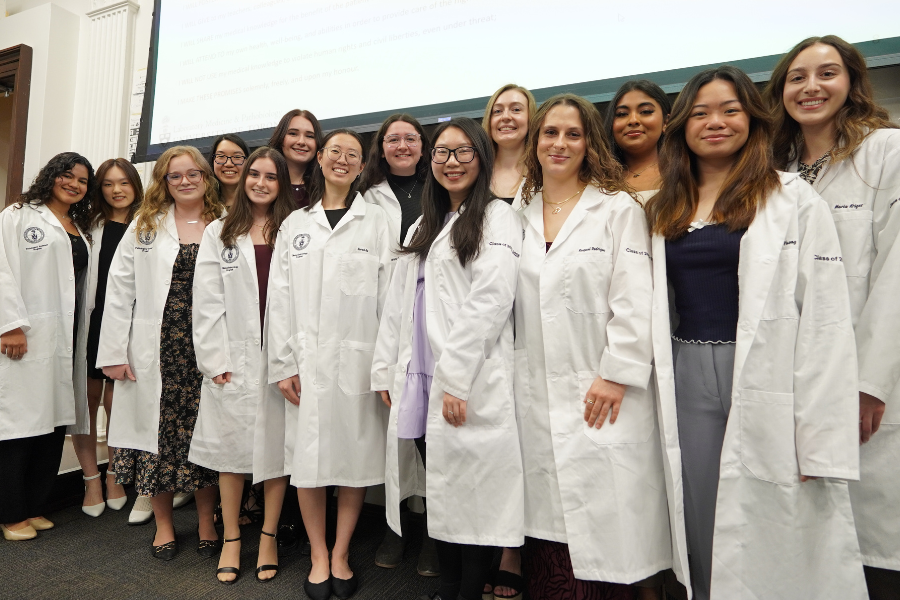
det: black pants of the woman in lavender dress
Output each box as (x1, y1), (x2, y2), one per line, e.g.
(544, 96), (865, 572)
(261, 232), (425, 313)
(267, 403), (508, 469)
(416, 436), (496, 600)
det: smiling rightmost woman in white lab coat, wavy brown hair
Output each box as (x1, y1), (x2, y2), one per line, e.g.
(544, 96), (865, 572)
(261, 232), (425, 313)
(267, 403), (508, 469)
(766, 36), (900, 598)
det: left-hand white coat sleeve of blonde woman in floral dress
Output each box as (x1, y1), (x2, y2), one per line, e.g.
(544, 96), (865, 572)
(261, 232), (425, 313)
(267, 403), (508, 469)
(96, 223), (136, 369)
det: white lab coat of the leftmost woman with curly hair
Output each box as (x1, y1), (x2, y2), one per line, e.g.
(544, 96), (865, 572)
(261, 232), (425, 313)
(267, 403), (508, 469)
(0, 204), (93, 440)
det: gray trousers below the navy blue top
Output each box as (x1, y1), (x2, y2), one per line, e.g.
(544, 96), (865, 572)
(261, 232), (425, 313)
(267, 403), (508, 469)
(672, 341), (734, 600)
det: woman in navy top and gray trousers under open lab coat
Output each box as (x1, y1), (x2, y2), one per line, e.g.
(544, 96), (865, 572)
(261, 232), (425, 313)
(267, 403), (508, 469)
(646, 66), (866, 600)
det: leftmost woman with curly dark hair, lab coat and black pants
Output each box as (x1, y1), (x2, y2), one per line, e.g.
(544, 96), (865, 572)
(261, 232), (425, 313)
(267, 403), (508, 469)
(0, 152), (96, 540)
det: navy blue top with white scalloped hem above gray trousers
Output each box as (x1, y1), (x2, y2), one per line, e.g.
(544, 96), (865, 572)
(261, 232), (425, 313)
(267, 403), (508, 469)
(666, 224), (747, 343)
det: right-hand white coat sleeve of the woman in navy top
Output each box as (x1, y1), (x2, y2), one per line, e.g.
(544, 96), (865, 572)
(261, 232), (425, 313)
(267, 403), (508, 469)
(793, 186), (859, 479)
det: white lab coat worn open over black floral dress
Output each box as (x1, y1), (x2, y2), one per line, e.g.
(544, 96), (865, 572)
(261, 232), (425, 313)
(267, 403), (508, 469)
(97, 209), (180, 454)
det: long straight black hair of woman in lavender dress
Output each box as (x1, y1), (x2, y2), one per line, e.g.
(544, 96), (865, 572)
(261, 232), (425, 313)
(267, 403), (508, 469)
(400, 117), (495, 266)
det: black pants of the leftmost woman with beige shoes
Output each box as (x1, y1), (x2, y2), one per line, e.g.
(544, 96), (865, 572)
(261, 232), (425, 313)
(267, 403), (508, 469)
(0, 425), (66, 524)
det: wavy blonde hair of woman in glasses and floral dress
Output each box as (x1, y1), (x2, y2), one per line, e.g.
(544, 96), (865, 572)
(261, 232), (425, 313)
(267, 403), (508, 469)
(134, 146), (225, 234)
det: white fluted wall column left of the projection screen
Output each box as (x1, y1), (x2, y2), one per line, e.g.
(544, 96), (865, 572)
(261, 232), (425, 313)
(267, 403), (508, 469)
(81, 0), (139, 165)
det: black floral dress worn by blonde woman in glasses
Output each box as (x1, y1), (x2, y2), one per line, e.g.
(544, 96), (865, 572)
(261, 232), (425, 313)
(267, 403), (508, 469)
(115, 244), (219, 496)
